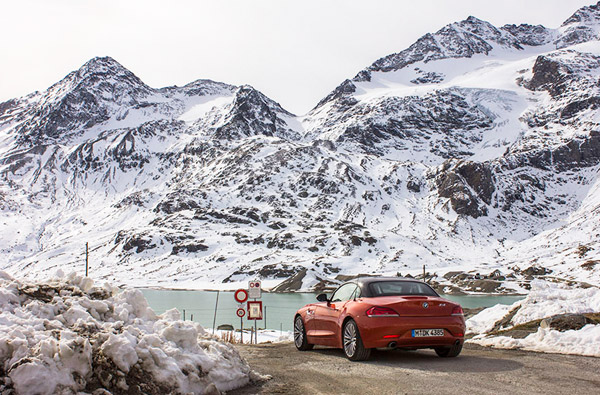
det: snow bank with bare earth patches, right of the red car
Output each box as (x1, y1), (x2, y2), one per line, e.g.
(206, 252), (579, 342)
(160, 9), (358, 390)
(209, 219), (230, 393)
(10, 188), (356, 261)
(467, 281), (600, 357)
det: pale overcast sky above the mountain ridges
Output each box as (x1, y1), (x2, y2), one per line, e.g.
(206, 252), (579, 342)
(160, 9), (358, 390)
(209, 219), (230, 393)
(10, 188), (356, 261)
(0, 0), (593, 114)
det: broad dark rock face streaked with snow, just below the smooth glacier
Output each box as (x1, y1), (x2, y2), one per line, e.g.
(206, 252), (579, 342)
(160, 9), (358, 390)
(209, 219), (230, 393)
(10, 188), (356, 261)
(309, 89), (494, 162)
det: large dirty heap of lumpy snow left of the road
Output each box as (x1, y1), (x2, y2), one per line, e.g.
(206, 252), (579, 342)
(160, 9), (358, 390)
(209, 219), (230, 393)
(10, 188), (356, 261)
(0, 272), (259, 394)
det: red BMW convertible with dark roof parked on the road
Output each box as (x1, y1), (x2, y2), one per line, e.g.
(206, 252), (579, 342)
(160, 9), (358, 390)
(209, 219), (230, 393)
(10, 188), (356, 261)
(294, 277), (465, 361)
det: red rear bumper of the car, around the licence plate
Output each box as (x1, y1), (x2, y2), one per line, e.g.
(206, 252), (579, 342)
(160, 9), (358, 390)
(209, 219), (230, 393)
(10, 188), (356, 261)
(356, 316), (466, 348)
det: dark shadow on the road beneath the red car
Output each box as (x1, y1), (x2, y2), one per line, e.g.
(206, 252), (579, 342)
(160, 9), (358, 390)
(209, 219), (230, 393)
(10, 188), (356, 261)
(311, 348), (523, 373)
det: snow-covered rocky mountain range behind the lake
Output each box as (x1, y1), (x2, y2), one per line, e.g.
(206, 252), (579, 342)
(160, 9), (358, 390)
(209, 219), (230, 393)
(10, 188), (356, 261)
(0, 3), (600, 289)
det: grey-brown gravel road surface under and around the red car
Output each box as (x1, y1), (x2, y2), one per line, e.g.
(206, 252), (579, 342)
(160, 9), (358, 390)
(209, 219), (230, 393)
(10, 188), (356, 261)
(227, 343), (600, 395)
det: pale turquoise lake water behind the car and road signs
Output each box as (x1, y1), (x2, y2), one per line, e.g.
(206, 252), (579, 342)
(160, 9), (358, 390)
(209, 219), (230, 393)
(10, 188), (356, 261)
(141, 289), (524, 331)
